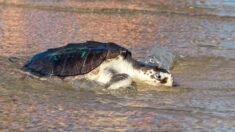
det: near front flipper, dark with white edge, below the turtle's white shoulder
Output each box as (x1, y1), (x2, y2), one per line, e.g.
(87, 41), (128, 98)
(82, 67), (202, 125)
(105, 74), (132, 90)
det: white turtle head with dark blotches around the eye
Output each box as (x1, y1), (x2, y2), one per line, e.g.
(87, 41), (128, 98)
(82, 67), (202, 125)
(140, 67), (173, 87)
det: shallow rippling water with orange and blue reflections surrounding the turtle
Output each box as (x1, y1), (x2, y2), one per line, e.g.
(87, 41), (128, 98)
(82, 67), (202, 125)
(0, 0), (235, 131)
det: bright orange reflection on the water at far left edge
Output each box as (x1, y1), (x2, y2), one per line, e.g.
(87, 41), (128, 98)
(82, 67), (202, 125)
(0, 3), (26, 54)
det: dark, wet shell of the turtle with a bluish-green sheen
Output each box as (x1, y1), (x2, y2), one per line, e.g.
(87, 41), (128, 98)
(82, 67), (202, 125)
(23, 41), (131, 77)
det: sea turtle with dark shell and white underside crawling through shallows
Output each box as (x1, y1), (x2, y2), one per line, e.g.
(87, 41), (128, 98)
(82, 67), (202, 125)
(23, 41), (173, 89)
